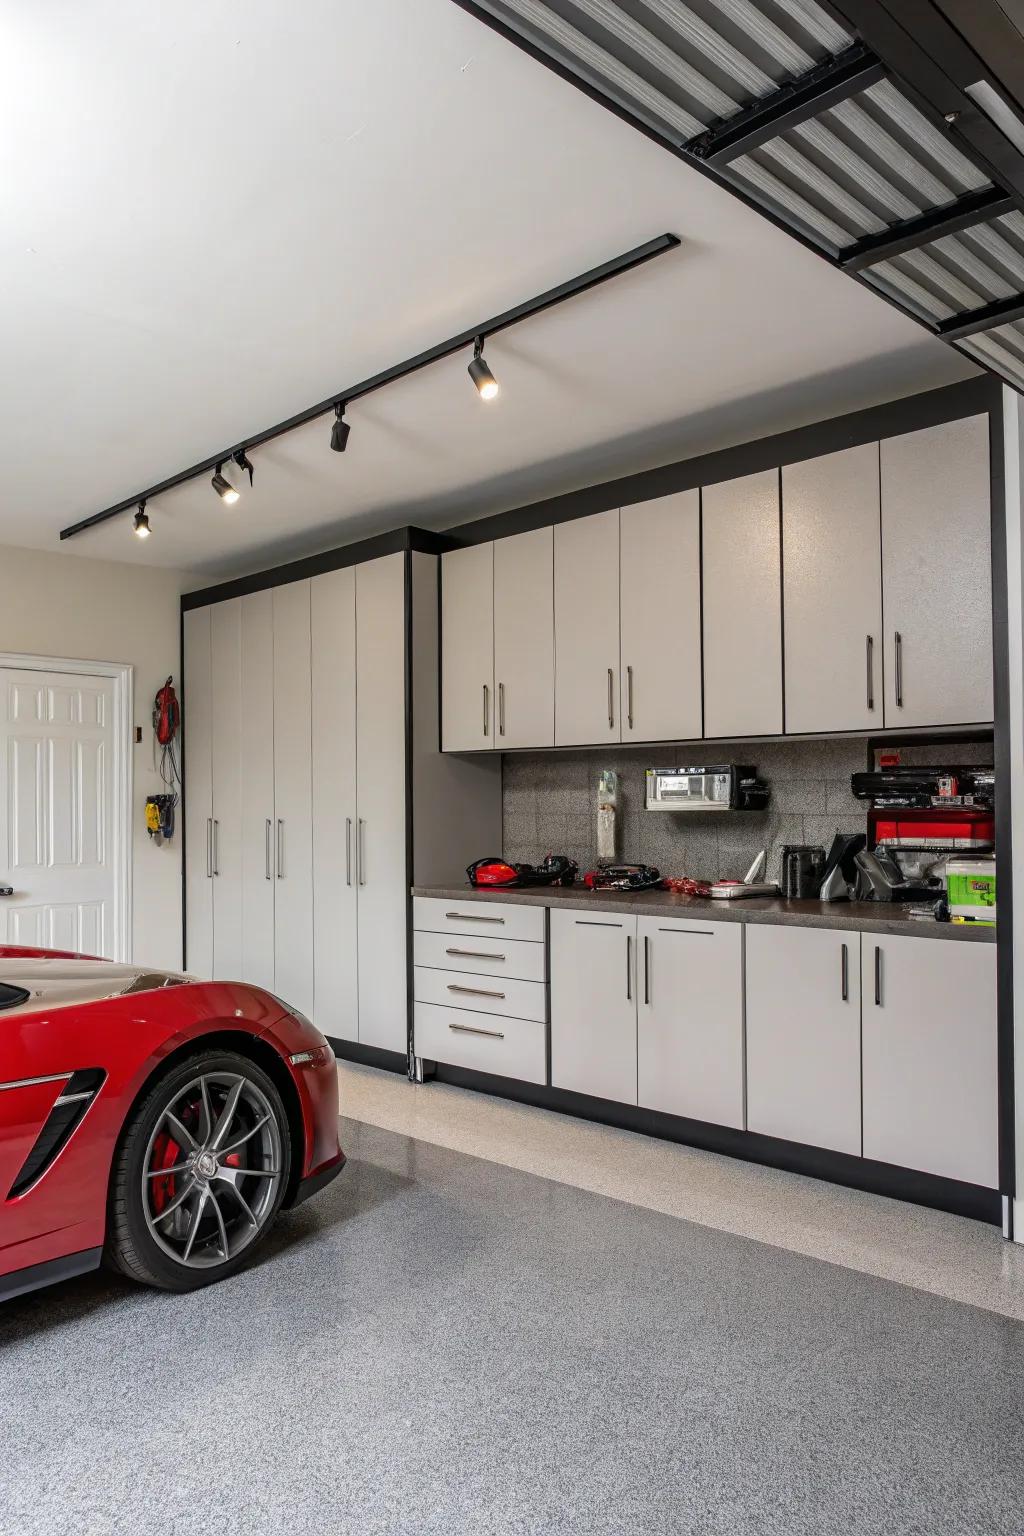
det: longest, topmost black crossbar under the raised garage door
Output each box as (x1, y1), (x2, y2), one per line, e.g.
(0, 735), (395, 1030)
(685, 43), (886, 166)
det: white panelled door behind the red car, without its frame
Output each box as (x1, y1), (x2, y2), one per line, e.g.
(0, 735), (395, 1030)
(0, 667), (118, 958)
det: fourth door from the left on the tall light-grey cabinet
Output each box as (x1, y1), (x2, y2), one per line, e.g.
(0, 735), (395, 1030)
(273, 581), (313, 1014)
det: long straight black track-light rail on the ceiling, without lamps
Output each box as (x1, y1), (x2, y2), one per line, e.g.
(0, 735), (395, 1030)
(60, 235), (680, 539)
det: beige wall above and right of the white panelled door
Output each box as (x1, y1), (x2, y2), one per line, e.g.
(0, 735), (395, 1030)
(0, 547), (198, 966)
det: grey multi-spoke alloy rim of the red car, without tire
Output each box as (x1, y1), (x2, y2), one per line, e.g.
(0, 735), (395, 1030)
(141, 1072), (282, 1269)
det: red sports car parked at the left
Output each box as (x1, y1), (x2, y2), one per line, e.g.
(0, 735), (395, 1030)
(0, 946), (344, 1298)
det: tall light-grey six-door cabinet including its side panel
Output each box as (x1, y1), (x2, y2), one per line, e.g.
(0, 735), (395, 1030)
(183, 550), (500, 1054)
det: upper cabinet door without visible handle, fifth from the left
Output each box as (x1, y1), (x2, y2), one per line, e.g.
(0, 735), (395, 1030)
(700, 470), (783, 736)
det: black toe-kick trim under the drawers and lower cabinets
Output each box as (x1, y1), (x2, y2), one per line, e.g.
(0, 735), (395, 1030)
(433, 1063), (1003, 1226)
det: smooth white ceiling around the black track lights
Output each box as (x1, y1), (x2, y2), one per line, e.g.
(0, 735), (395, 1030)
(0, 0), (972, 574)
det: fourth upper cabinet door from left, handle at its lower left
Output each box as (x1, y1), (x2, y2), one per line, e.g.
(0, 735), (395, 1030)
(619, 490), (702, 742)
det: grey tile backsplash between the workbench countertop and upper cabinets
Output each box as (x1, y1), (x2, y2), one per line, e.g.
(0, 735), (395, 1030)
(502, 737), (992, 880)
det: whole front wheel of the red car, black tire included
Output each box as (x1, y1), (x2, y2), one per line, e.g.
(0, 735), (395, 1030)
(104, 1049), (292, 1292)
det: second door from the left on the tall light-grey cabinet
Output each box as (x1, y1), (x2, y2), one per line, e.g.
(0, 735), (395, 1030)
(210, 598), (243, 982)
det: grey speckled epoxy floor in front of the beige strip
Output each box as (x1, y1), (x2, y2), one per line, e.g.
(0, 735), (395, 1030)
(0, 1121), (1024, 1536)
